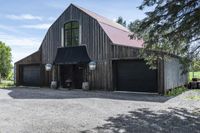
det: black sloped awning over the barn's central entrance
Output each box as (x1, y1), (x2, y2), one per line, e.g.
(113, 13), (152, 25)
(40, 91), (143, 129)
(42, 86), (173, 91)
(54, 46), (91, 65)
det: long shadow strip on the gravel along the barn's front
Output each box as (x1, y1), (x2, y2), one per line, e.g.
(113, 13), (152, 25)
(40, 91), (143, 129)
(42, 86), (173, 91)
(8, 88), (170, 103)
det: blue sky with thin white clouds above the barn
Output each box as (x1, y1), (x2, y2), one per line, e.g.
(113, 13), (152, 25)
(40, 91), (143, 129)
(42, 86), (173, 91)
(0, 0), (145, 63)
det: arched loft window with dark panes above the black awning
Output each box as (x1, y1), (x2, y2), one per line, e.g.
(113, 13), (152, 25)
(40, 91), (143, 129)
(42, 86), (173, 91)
(64, 21), (79, 46)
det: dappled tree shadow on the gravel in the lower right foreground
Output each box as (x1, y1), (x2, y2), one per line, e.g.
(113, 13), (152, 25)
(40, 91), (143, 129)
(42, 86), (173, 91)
(82, 108), (200, 133)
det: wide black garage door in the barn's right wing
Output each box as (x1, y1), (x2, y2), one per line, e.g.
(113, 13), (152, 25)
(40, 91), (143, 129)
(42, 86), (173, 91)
(114, 60), (157, 92)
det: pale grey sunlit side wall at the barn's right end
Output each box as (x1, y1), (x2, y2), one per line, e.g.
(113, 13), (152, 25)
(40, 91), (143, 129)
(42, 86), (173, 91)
(164, 58), (188, 91)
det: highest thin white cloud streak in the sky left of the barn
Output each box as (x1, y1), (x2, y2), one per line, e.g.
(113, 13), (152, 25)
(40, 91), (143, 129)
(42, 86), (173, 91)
(6, 14), (43, 21)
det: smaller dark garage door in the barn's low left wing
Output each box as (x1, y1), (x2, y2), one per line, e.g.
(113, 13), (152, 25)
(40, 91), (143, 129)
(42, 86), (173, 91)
(23, 65), (40, 86)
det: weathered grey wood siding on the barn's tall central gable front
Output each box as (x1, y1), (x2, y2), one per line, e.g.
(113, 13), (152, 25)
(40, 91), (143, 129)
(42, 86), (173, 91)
(41, 5), (112, 90)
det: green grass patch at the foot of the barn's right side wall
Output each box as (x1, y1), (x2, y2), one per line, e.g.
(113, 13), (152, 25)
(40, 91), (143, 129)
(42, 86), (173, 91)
(165, 86), (187, 96)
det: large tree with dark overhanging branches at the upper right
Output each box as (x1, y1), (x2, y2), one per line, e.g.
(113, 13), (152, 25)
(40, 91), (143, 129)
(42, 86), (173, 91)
(129, 0), (200, 70)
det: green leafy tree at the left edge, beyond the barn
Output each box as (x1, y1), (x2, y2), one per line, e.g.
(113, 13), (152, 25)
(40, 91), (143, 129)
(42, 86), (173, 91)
(0, 41), (12, 82)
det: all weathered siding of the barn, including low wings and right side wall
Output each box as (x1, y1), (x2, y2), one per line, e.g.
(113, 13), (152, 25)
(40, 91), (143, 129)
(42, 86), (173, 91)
(16, 5), (186, 93)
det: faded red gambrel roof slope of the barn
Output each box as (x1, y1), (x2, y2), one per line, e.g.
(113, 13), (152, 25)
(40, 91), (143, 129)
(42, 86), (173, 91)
(72, 4), (143, 48)
